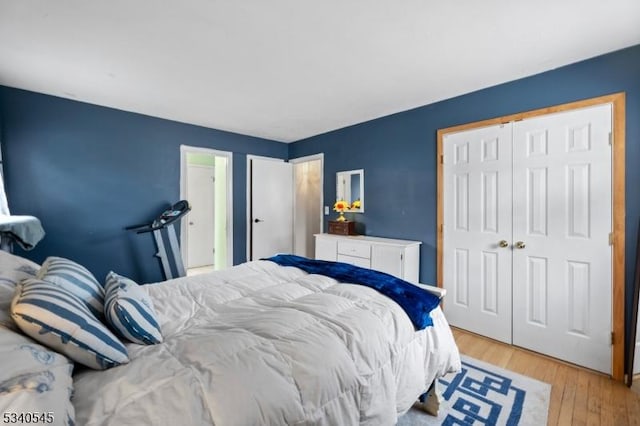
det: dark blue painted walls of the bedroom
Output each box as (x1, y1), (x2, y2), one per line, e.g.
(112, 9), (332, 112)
(0, 46), (640, 352)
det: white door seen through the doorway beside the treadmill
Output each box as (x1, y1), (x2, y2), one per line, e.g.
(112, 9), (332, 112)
(185, 164), (215, 268)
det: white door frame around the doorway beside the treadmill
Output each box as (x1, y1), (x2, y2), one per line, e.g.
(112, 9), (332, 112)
(180, 145), (233, 267)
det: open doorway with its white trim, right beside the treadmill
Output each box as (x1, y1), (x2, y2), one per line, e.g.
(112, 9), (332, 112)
(180, 145), (233, 275)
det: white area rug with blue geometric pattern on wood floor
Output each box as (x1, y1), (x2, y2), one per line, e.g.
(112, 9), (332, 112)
(397, 356), (551, 426)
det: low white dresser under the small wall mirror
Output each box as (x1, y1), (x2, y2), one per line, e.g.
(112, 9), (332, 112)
(315, 234), (422, 283)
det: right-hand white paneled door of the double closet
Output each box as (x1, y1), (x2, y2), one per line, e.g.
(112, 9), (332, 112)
(513, 105), (612, 373)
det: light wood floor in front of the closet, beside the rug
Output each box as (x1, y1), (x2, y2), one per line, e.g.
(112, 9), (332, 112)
(453, 328), (640, 426)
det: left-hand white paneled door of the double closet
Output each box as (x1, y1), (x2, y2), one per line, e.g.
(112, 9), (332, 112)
(443, 124), (512, 343)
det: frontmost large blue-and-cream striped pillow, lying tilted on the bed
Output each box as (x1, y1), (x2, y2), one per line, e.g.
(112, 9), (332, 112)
(11, 278), (129, 370)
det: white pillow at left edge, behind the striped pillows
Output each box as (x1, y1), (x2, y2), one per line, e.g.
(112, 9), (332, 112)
(0, 250), (40, 331)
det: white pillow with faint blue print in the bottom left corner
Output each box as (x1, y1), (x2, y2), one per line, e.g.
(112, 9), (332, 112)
(0, 326), (75, 425)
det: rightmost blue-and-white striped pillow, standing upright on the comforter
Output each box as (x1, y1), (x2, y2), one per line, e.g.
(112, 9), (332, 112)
(104, 272), (162, 345)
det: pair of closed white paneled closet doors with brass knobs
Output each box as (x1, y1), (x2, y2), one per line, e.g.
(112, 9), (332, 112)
(443, 105), (612, 373)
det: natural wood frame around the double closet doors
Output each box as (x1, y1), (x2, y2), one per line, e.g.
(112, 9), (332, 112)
(436, 92), (626, 381)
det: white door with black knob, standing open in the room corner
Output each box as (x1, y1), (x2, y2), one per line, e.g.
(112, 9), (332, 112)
(249, 158), (293, 260)
